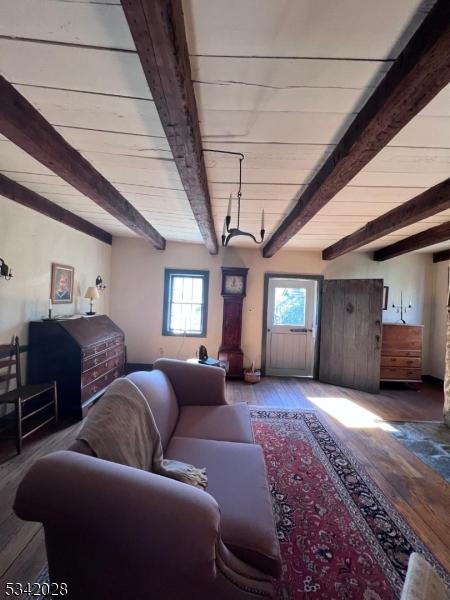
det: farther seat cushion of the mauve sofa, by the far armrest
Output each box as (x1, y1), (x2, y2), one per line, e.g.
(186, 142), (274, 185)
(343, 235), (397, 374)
(174, 402), (253, 444)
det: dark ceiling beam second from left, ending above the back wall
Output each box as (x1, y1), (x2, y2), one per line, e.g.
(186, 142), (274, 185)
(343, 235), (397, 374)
(0, 75), (166, 250)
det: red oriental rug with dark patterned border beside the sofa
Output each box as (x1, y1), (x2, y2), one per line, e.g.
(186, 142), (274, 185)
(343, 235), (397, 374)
(251, 407), (450, 600)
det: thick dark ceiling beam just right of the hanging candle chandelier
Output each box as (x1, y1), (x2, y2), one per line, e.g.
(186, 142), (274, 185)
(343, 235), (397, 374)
(263, 0), (450, 258)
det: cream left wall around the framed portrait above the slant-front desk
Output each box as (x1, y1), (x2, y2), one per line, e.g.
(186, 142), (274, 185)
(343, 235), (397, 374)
(0, 197), (111, 350)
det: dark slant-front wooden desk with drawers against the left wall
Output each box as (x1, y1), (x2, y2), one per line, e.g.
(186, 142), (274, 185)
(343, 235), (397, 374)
(27, 315), (125, 419)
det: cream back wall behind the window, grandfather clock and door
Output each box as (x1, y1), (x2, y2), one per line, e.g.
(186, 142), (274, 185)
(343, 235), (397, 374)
(107, 238), (431, 365)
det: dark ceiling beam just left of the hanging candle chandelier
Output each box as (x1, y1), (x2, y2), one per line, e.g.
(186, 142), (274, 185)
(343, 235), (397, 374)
(121, 0), (218, 254)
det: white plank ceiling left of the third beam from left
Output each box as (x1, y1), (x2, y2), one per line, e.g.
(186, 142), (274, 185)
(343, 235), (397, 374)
(0, 0), (202, 243)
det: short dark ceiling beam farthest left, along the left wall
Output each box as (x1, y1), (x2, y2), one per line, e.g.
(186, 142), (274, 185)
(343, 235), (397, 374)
(0, 173), (112, 245)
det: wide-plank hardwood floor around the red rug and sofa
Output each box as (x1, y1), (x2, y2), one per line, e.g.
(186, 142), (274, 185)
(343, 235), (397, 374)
(0, 377), (450, 597)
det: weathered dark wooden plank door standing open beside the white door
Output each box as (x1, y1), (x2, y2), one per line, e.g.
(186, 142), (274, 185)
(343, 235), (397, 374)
(319, 279), (383, 393)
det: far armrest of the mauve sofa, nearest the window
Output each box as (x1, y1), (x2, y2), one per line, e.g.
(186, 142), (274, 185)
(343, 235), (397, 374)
(153, 358), (228, 406)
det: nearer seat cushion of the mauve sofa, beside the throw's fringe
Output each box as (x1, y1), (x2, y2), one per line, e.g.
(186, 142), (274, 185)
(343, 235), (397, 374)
(165, 436), (281, 577)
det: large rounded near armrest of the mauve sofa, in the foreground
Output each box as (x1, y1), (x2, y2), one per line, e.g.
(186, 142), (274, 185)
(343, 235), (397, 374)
(14, 451), (220, 581)
